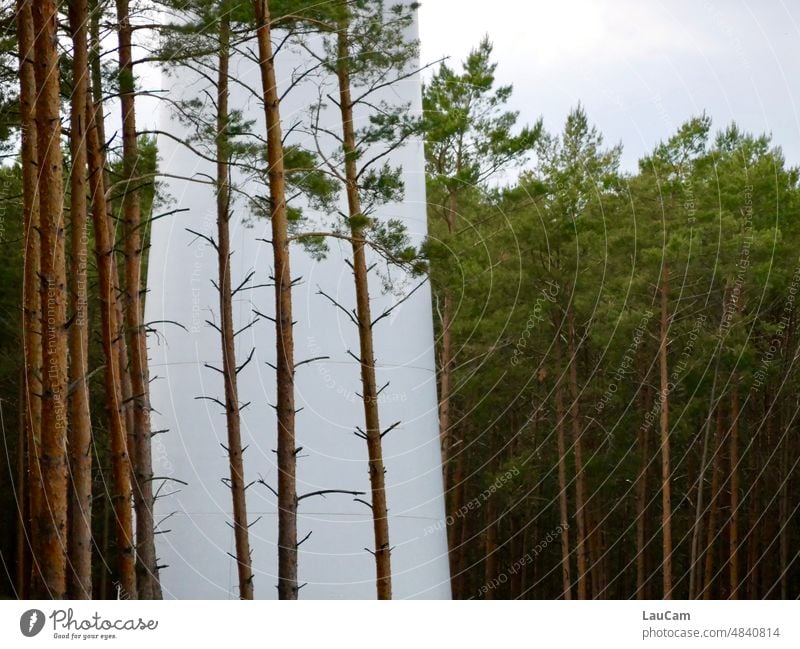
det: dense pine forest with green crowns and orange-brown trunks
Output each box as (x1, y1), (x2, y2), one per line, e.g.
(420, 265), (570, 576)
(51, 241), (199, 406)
(0, 0), (800, 599)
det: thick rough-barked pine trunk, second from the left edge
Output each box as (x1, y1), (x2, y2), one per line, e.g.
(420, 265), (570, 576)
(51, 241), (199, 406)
(32, 0), (68, 599)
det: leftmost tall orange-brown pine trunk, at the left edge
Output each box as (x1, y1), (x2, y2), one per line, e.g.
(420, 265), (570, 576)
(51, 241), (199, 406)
(16, 0), (42, 596)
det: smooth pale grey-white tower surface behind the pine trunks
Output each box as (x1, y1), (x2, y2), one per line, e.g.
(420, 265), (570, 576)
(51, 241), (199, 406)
(145, 7), (450, 599)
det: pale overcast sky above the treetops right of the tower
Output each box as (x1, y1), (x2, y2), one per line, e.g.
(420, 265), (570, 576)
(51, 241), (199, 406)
(420, 0), (800, 170)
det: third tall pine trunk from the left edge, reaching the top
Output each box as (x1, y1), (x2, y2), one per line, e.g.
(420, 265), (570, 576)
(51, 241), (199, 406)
(69, 0), (92, 599)
